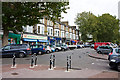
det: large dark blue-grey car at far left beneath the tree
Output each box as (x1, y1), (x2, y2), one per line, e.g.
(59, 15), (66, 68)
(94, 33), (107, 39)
(0, 44), (31, 58)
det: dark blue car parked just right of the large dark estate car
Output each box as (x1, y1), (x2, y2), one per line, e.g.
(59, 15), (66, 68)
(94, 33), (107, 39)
(30, 44), (46, 54)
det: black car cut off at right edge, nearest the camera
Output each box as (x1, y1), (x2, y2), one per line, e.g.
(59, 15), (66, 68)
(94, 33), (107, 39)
(109, 55), (120, 72)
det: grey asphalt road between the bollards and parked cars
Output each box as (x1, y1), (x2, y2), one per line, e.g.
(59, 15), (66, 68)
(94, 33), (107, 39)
(2, 48), (115, 71)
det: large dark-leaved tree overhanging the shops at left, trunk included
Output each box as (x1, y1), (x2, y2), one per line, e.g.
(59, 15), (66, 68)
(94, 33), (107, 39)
(2, 2), (69, 46)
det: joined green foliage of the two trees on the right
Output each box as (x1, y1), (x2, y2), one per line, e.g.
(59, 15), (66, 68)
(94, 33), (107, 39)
(75, 12), (120, 42)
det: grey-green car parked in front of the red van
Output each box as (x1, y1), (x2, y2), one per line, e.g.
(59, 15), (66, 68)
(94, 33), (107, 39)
(96, 46), (112, 54)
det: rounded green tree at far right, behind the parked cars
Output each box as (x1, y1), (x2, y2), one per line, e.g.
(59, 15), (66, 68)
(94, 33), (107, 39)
(97, 14), (119, 42)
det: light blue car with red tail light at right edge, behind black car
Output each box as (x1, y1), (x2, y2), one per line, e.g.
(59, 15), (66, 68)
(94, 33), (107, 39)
(108, 48), (120, 61)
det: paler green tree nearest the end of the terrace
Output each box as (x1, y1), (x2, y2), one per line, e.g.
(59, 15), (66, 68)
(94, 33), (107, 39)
(75, 12), (97, 41)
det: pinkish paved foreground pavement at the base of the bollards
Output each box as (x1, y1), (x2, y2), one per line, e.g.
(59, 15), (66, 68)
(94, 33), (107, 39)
(2, 64), (118, 78)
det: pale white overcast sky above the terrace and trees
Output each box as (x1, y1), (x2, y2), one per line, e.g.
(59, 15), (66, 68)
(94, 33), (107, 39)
(61, 0), (120, 26)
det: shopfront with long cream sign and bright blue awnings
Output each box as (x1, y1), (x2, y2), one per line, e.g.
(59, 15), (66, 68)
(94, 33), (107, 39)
(22, 34), (48, 45)
